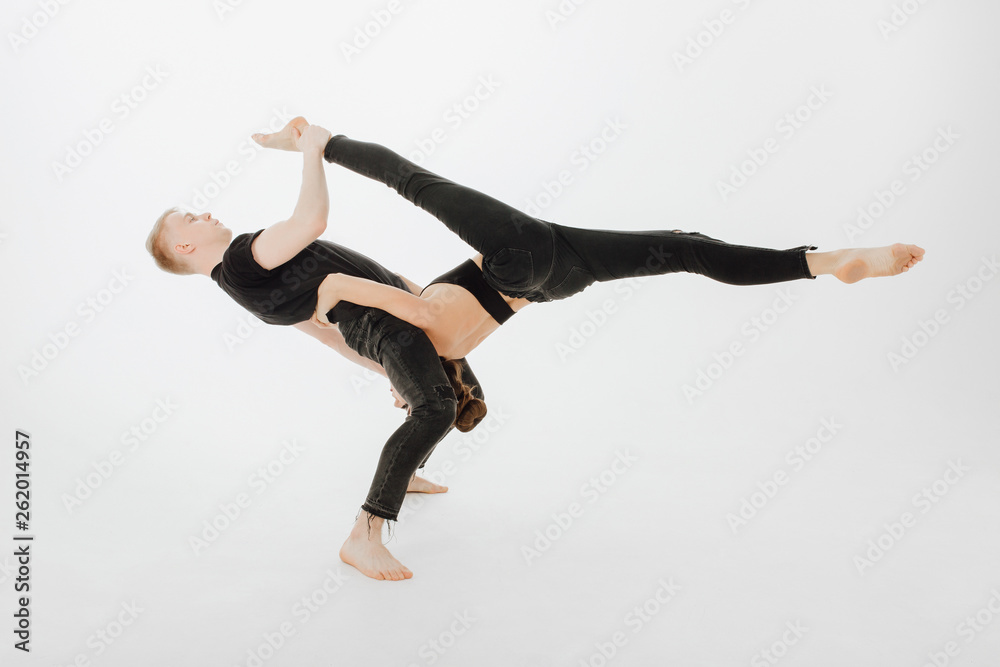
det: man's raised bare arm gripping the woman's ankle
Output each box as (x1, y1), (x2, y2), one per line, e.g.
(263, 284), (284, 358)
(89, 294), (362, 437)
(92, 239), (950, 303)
(250, 125), (330, 269)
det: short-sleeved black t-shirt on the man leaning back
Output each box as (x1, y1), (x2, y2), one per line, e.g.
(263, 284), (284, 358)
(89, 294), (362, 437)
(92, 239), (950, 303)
(212, 229), (409, 325)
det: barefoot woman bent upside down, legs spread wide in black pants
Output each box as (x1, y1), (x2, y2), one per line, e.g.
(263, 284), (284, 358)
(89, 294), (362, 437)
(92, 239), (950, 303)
(300, 135), (924, 362)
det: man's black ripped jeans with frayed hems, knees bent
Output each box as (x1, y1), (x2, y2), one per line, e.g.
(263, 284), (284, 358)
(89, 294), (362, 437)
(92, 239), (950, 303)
(338, 308), (485, 520)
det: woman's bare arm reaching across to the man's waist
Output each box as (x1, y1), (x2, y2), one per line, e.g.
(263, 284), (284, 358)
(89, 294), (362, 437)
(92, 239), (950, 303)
(310, 273), (431, 327)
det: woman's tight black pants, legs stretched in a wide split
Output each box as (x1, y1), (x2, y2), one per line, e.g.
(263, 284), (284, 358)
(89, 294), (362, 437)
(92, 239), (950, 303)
(324, 134), (816, 301)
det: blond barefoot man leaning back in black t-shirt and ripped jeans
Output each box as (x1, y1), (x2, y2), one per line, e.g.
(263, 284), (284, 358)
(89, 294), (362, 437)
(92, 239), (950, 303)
(146, 117), (483, 580)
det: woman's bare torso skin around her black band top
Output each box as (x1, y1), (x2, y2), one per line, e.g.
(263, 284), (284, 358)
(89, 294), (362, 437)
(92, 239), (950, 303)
(420, 255), (531, 359)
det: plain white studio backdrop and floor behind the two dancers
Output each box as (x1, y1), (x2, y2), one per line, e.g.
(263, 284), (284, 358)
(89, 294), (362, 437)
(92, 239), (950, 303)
(0, 0), (1000, 667)
